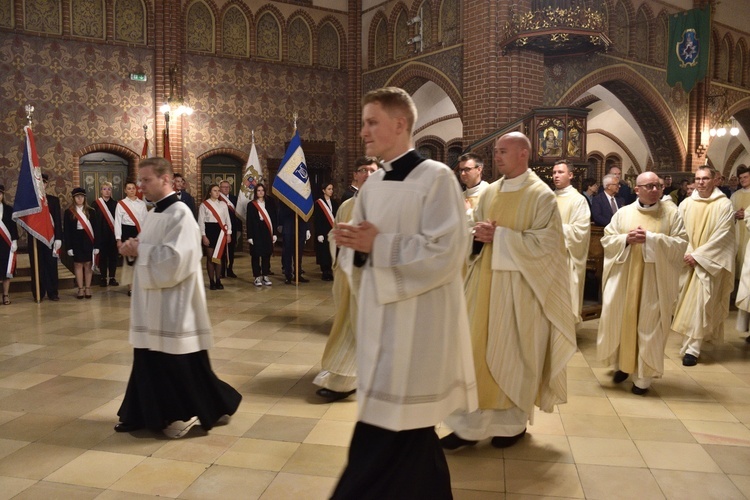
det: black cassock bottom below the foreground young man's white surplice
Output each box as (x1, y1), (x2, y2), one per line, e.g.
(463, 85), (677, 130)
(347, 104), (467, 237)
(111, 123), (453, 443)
(331, 422), (453, 500)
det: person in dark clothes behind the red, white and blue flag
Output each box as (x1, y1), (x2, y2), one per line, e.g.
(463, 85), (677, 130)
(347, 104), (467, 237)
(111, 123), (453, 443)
(29, 174), (63, 302)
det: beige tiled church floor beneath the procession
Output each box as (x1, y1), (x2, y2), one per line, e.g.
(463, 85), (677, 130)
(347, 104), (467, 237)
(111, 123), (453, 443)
(0, 255), (750, 500)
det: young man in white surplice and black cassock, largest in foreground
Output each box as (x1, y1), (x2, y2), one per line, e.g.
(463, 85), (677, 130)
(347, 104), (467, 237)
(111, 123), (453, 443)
(332, 87), (477, 499)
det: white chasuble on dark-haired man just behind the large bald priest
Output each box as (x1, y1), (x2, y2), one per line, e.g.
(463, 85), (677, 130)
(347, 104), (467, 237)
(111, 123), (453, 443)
(555, 186), (591, 323)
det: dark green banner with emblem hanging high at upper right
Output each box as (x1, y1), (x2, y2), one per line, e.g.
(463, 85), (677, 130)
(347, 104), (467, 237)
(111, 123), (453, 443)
(667, 5), (711, 92)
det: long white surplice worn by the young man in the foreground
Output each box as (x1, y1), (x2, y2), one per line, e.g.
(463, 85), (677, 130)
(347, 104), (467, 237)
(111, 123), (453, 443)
(339, 160), (476, 431)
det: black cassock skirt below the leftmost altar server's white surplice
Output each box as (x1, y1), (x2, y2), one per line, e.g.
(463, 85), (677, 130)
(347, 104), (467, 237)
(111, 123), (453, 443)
(117, 349), (242, 431)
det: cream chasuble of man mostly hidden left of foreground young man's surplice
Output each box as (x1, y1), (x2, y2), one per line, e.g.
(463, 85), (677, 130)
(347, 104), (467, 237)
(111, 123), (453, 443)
(313, 198), (357, 392)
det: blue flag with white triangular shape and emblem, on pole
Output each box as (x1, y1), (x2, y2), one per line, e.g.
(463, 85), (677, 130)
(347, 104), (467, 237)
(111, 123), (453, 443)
(273, 130), (313, 222)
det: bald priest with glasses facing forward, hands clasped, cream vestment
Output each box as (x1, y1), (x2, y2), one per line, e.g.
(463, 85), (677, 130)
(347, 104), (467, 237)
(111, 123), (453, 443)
(597, 172), (688, 395)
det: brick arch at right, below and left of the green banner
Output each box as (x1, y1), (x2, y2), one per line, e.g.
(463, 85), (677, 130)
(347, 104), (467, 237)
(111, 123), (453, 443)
(556, 64), (687, 170)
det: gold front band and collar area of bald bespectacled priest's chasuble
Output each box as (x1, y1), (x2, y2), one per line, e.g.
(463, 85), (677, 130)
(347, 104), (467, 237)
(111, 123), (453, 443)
(619, 206), (664, 373)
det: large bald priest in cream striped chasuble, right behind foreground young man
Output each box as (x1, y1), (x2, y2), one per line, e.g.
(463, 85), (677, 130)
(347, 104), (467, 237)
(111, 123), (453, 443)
(441, 132), (576, 449)
